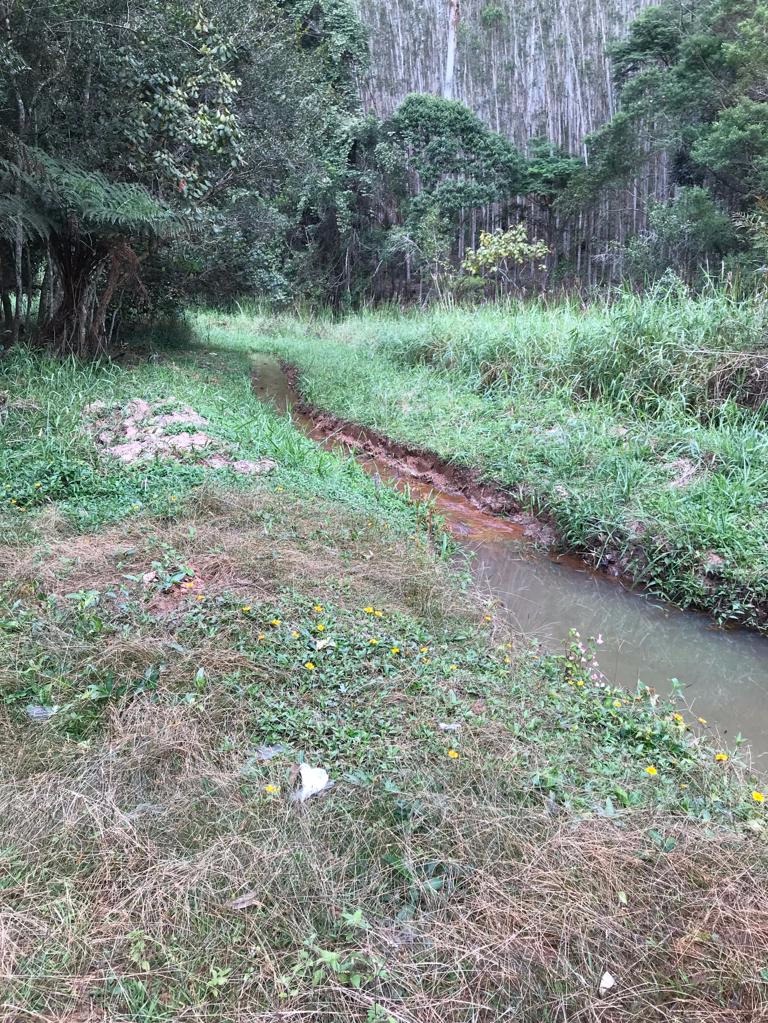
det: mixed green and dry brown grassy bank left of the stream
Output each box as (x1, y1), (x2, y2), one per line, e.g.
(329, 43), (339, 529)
(0, 320), (768, 1023)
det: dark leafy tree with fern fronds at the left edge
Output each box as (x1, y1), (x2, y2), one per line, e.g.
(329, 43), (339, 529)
(0, 0), (240, 355)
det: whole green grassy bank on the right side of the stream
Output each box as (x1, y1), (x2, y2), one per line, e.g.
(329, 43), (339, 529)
(213, 292), (768, 630)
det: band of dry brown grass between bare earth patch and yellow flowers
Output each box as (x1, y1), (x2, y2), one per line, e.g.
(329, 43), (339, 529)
(0, 487), (471, 619)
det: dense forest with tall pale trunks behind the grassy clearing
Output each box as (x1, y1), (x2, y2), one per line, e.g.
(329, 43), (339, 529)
(0, 0), (768, 353)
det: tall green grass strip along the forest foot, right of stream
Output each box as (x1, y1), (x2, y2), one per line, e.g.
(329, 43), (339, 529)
(312, 286), (768, 414)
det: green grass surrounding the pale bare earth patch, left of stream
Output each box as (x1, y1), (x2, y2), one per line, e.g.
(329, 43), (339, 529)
(0, 337), (427, 538)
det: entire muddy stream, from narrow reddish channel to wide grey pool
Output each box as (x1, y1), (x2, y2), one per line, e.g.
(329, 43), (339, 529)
(254, 356), (768, 769)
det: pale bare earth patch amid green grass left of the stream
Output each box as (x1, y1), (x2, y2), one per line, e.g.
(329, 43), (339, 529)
(84, 398), (277, 476)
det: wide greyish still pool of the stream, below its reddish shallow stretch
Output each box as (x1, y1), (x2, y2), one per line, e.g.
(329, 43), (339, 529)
(471, 541), (768, 755)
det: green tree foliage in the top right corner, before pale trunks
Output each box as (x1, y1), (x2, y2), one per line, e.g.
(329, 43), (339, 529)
(587, 0), (768, 209)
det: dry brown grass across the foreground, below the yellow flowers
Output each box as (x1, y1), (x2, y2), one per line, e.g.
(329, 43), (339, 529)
(0, 703), (768, 1023)
